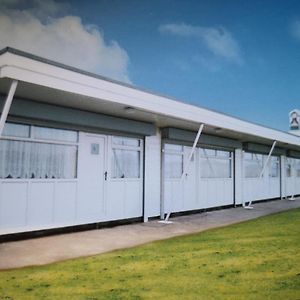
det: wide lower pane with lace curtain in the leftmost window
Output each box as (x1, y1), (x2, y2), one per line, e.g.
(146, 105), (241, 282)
(0, 140), (77, 179)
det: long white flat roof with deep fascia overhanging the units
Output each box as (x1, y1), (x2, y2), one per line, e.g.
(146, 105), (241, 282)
(0, 47), (300, 148)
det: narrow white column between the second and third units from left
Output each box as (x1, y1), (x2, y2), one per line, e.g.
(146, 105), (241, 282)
(234, 149), (244, 205)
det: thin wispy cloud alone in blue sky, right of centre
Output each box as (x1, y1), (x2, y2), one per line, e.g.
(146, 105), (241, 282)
(159, 23), (243, 64)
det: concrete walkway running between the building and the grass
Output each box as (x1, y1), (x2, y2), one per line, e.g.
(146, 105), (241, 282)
(0, 198), (300, 269)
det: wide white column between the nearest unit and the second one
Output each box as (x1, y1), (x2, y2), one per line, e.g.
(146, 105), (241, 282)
(144, 130), (161, 222)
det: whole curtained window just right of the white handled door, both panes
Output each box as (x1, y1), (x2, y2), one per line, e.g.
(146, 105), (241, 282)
(111, 137), (141, 179)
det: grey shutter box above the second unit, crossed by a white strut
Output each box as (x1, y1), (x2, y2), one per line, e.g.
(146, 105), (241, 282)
(162, 128), (242, 149)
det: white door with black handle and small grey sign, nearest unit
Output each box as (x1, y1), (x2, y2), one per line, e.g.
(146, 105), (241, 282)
(77, 134), (107, 223)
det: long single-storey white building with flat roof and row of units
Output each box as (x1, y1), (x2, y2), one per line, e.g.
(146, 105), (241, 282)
(0, 48), (300, 236)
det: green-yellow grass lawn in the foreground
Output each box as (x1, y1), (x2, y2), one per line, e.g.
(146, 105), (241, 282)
(0, 209), (300, 300)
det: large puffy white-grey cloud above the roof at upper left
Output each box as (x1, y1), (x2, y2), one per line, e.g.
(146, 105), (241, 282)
(0, 0), (130, 82)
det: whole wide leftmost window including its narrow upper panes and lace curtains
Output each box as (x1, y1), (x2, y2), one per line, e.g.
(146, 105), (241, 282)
(0, 123), (77, 179)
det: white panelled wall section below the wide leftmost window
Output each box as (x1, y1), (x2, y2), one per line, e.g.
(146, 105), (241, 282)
(0, 179), (77, 234)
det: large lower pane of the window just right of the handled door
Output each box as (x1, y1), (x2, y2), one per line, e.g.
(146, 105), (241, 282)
(112, 149), (140, 178)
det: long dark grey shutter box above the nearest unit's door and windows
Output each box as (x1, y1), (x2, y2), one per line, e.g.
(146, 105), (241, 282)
(0, 96), (156, 136)
